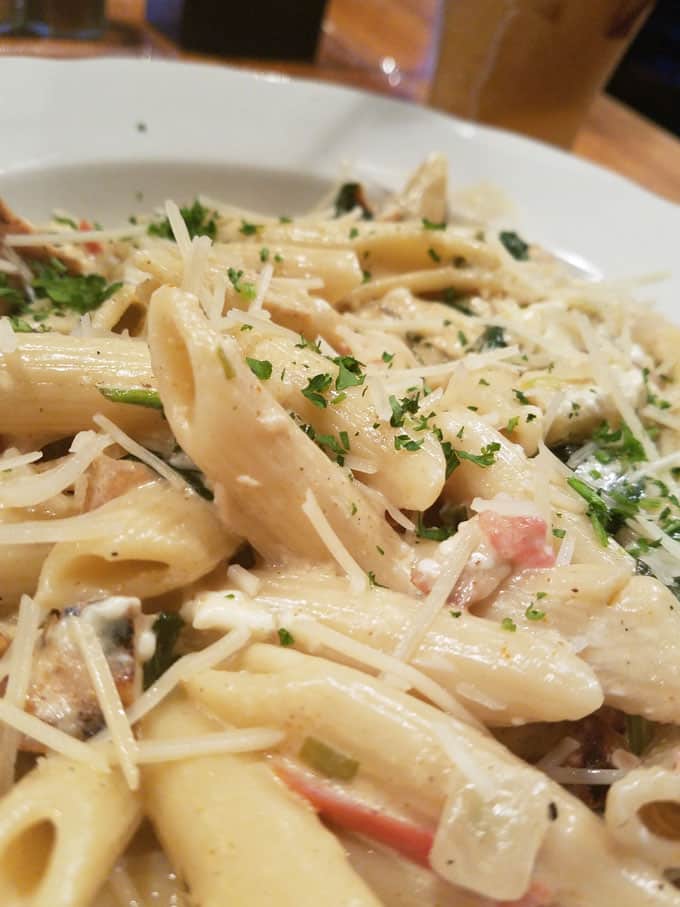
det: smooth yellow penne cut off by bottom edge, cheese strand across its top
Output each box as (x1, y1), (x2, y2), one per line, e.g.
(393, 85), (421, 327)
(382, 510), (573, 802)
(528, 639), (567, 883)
(143, 698), (380, 907)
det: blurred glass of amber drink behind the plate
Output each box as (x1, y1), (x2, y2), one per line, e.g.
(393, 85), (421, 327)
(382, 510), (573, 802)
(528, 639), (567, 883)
(430, 0), (654, 148)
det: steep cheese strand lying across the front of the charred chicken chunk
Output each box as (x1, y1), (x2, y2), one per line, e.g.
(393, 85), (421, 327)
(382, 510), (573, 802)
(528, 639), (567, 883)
(70, 618), (139, 790)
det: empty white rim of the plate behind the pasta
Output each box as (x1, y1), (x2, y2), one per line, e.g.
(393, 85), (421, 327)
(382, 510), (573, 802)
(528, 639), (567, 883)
(0, 59), (680, 318)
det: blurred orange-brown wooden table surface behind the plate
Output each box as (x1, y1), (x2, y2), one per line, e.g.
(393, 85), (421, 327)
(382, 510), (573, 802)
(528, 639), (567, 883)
(0, 0), (680, 203)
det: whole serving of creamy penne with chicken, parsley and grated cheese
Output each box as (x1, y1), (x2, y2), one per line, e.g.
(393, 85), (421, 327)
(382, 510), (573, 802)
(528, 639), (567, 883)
(0, 155), (680, 907)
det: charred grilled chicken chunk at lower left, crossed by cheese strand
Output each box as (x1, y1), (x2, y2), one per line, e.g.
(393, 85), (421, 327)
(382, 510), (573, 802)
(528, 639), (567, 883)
(0, 596), (139, 753)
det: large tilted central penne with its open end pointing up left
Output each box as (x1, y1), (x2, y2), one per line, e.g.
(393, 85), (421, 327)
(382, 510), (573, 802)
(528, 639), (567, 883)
(149, 288), (411, 591)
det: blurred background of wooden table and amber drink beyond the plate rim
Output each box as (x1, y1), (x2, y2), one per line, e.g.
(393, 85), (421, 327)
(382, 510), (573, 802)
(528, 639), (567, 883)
(0, 0), (680, 202)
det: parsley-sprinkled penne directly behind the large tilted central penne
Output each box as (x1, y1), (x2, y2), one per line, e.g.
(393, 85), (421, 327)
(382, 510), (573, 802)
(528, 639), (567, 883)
(235, 331), (445, 510)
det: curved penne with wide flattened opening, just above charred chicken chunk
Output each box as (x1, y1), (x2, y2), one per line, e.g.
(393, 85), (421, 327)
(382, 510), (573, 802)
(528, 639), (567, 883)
(36, 481), (239, 609)
